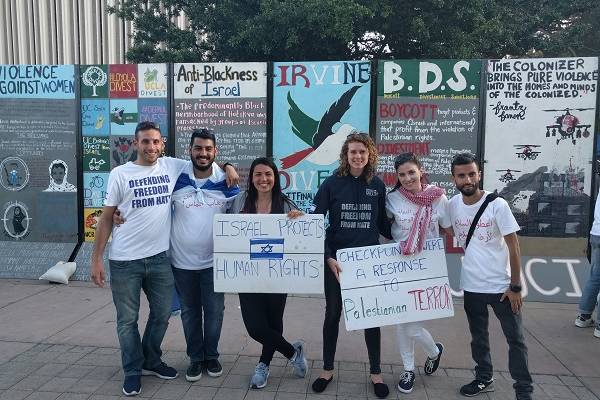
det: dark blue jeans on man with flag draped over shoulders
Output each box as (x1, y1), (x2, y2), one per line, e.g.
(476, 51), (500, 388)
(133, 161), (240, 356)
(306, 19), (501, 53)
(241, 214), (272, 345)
(173, 267), (225, 362)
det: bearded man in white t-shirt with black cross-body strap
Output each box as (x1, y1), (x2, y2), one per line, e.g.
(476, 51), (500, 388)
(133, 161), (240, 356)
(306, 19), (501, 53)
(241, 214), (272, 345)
(448, 153), (533, 400)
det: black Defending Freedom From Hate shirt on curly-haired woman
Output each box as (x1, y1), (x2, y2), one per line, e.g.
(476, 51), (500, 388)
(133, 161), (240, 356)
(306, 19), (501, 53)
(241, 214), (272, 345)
(312, 170), (391, 260)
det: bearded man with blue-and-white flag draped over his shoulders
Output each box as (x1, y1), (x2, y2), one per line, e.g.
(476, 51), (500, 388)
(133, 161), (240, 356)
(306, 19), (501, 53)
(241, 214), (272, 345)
(171, 129), (239, 382)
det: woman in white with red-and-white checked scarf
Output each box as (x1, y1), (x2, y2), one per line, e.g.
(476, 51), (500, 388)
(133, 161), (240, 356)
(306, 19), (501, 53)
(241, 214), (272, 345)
(386, 153), (450, 393)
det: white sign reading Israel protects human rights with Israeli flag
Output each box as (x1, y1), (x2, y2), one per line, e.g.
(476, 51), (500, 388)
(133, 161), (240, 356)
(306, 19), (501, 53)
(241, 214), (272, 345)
(213, 214), (325, 293)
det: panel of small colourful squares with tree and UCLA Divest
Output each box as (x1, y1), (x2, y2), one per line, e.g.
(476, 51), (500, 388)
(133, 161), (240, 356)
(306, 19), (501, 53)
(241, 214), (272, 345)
(77, 63), (169, 242)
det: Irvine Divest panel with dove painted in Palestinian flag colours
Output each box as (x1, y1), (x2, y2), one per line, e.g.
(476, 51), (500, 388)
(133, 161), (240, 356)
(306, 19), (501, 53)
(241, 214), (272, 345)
(272, 61), (371, 212)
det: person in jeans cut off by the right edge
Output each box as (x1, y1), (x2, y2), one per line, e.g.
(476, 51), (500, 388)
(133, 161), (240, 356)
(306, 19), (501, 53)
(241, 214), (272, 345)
(575, 186), (600, 338)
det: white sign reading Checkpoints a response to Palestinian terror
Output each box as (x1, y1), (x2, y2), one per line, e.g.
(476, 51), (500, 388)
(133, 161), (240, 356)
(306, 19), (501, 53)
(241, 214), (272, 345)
(337, 238), (454, 331)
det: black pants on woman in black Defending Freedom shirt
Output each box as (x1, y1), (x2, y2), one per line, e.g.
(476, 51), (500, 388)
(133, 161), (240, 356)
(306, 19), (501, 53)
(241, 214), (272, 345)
(323, 262), (381, 374)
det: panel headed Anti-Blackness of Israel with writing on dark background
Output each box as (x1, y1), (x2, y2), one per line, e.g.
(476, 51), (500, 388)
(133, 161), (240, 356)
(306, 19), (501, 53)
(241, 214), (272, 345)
(173, 62), (268, 189)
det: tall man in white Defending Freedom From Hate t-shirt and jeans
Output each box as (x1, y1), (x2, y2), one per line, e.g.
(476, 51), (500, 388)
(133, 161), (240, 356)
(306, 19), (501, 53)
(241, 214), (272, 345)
(91, 122), (187, 396)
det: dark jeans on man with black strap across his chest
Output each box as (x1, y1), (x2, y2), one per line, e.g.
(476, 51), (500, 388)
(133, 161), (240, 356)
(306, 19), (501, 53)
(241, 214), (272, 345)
(463, 291), (533, 400)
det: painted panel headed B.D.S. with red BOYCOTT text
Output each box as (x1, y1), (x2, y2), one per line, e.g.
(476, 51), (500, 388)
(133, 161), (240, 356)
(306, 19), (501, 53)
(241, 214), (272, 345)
(375, 60), (481, 197)
